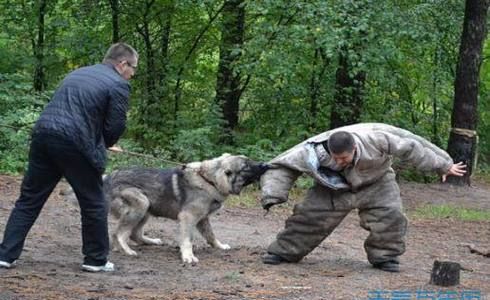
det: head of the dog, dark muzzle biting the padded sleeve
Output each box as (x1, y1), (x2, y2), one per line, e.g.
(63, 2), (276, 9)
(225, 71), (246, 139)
(201, 153), (269, 195)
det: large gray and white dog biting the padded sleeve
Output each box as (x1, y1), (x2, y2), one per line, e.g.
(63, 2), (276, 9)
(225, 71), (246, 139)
(104, 154), (268, 263)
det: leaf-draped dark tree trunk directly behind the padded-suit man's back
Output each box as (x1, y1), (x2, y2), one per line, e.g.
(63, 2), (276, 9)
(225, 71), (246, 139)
(330, 50), (366, 129)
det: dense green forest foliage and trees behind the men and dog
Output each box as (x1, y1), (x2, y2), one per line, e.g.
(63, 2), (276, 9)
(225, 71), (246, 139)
(0, 0), (490, 184)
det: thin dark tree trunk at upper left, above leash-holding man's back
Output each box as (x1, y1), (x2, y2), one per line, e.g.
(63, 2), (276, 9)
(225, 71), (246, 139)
(33, 0), (46, 92)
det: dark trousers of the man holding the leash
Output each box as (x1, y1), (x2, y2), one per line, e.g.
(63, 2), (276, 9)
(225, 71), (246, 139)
(0, 133), (109, 265)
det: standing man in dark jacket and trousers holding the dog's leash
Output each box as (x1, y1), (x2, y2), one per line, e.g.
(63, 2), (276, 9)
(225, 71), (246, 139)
(0, 43), (138, 272)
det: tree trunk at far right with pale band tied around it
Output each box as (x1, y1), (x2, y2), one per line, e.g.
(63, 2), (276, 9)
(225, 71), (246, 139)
(448, 0), (490, 185)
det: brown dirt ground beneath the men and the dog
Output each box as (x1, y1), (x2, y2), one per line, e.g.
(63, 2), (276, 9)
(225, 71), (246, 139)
(0, 176), (490, 300)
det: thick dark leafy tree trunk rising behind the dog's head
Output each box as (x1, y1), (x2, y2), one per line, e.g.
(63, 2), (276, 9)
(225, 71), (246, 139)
(215, 0), (245, 142)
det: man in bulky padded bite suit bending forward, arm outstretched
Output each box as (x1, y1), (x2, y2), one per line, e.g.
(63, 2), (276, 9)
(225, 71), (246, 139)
(261, 123), (466, 272)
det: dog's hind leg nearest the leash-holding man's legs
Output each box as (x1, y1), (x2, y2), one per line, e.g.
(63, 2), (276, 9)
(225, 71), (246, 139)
(113, 188), (150, 255)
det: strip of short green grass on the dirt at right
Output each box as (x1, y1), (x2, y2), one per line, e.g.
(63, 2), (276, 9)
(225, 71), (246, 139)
(412, 204), (490, 221)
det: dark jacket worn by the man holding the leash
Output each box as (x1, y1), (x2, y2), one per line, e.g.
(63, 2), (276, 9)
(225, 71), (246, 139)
(34, 64), (130, 173)
